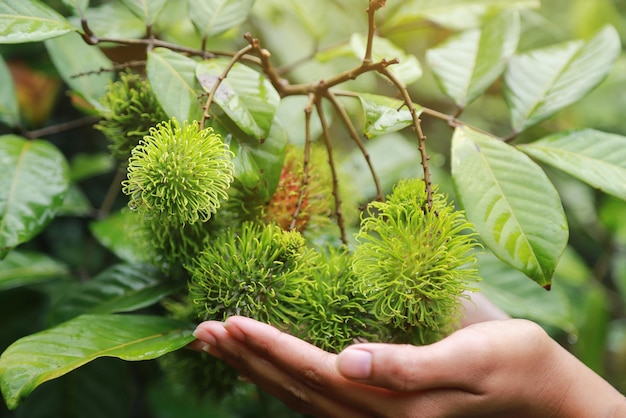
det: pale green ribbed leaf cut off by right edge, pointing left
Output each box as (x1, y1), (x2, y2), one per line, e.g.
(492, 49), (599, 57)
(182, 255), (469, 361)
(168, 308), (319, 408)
(519, 129), (626, 200)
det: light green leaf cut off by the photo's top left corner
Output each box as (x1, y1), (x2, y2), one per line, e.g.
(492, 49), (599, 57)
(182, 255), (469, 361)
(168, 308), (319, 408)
(0, 0), (76, 44)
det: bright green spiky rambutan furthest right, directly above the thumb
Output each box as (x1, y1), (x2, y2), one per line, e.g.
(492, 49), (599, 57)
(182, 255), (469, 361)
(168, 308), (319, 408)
(352, 179), (479, 344)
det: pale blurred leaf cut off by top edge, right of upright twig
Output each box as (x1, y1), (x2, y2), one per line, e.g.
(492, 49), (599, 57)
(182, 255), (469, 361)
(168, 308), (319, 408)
(383, 0), (540, 30)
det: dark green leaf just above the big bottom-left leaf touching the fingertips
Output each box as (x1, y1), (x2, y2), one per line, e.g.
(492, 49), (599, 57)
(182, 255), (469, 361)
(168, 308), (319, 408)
(52, 264), (181, 322)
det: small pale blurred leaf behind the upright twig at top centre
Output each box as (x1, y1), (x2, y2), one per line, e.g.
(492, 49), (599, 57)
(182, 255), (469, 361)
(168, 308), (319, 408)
(350, 33), (422, 86)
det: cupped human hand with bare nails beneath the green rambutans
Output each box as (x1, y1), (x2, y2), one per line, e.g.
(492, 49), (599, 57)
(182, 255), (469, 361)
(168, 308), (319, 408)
(193, 317), (626, 418)
